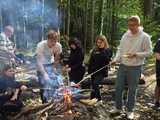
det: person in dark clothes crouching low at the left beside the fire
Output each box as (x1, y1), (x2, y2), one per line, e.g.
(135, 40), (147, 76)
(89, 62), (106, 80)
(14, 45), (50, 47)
(0, 65), (27, 114)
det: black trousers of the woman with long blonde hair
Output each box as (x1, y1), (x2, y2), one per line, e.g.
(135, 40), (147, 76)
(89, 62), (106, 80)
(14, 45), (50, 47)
(91, 74), (104, 101)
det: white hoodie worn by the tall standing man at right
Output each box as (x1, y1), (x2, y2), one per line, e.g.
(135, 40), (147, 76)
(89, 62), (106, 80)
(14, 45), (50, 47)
(114, 27), (152, 66)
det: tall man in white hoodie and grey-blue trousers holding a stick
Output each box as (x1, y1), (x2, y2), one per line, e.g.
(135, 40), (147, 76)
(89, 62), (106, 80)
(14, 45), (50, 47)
(112, 16), (152, 119)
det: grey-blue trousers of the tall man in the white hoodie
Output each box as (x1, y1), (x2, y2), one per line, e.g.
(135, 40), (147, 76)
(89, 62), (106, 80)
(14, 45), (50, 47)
(115, 64), (142, 112)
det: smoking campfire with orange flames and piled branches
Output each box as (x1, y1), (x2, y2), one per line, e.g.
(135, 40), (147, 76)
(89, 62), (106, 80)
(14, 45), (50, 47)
(10, 64), (99, 120)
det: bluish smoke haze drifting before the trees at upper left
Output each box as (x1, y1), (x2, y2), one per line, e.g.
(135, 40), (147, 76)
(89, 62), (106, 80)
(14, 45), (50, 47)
(0, 0), (60, 47)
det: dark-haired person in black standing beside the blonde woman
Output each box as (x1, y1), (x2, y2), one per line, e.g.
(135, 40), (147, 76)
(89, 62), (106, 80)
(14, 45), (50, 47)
(66, 38), (85, 83)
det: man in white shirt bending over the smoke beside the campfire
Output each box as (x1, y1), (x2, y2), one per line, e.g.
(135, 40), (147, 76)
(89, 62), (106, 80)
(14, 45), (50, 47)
(36, 30), (62, 103)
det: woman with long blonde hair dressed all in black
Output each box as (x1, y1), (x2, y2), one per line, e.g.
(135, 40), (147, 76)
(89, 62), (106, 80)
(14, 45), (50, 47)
(88, 35), (112, 101)
